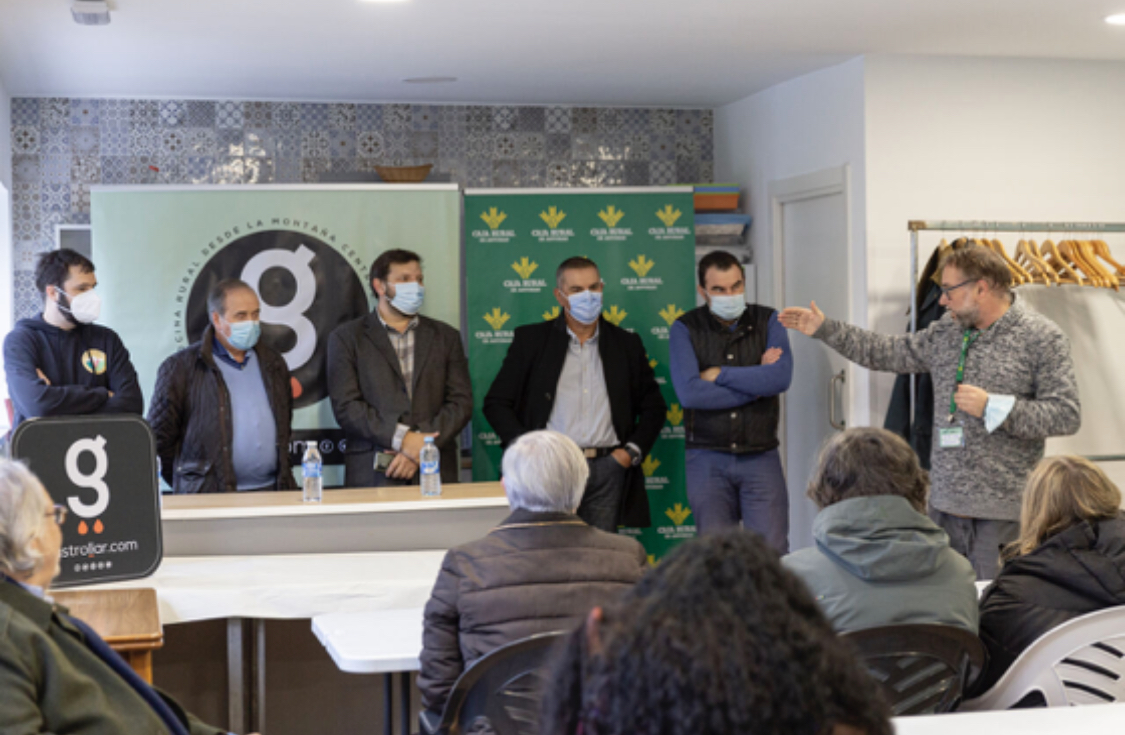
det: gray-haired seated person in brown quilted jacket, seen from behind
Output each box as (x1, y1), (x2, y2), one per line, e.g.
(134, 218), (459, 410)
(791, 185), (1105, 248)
(417, 431), (646, 716)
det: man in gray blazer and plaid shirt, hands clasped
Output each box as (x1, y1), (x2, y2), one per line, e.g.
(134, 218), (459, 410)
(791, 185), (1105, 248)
(329, 250), (473, 487)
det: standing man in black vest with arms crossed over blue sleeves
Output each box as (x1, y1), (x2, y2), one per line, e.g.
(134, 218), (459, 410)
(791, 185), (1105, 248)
(669, 250), (793, 554)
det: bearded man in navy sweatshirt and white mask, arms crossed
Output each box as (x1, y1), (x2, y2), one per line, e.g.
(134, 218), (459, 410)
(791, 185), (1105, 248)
(3, 248), (144, 429)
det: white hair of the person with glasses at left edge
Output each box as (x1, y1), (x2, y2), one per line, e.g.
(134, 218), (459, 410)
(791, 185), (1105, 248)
(0, 459), (51, 579)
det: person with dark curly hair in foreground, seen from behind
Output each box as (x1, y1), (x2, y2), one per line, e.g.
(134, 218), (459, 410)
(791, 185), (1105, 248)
(539, 530), (892, 735)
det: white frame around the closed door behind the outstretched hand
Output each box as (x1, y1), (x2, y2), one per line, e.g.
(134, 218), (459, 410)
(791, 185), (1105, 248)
(768, 163), (858, 466)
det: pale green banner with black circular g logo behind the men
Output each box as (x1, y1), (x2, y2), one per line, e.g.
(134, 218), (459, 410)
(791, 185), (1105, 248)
(91, 185), (461, 482)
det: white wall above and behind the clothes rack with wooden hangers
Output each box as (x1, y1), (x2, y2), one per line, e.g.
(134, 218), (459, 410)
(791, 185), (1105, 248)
(865, 55), (1125, 423)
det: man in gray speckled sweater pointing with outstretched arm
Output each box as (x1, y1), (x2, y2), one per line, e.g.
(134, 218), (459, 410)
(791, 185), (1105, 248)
(780, 245), (1081, 580)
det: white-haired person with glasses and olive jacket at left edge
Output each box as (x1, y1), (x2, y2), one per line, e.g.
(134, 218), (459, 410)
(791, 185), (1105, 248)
(0, 460), (246, 735)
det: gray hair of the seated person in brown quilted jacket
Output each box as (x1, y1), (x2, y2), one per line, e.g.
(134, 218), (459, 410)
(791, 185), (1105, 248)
(502, 431), (590, 513)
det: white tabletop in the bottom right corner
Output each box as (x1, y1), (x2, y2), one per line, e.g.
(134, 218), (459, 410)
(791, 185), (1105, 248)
(893, 705), (1125, 735)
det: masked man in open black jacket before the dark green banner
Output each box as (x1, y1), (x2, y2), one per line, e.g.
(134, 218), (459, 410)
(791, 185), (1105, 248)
(484, 258), (666, 531)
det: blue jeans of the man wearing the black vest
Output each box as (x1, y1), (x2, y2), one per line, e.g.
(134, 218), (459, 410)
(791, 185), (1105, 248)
(686, 449), (789, 554)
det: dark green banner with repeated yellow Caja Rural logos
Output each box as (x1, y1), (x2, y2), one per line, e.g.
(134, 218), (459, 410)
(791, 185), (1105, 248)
(465, 188), (695, 561)
